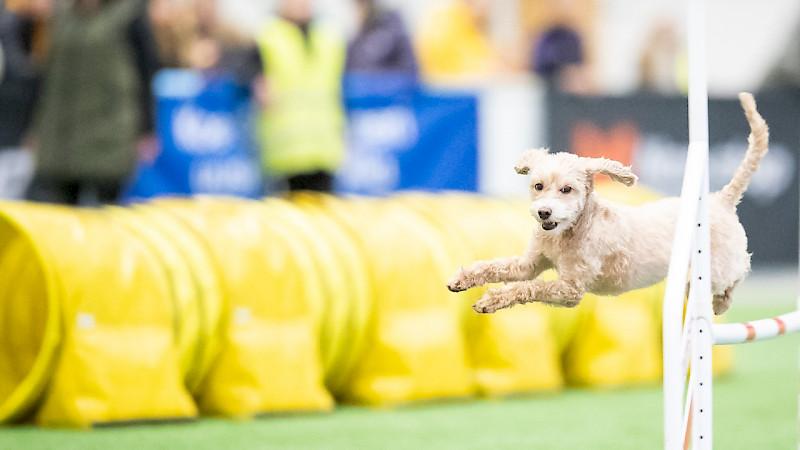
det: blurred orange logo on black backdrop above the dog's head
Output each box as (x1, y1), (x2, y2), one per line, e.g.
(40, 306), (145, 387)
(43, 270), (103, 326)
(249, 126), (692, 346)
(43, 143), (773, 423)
(572, 121), (639, 181)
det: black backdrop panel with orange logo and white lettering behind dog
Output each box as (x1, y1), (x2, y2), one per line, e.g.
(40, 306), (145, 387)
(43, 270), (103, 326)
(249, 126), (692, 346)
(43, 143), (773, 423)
(547, 92), (800, 265)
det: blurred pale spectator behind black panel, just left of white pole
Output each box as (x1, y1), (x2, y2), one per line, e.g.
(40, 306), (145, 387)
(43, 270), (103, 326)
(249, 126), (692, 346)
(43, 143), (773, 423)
(639, 20), (688, 94)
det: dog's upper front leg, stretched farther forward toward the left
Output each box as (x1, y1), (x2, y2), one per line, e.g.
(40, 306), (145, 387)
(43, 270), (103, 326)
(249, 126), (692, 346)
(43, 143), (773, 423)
(447, 256), (545, 292)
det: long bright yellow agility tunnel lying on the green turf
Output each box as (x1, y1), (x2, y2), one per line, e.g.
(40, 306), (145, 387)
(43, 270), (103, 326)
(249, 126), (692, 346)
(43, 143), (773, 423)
(0, 191), (730, 427)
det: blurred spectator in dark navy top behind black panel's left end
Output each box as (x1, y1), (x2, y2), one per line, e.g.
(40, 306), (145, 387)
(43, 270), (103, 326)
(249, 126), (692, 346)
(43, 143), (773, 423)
(531, 0), (597, 94)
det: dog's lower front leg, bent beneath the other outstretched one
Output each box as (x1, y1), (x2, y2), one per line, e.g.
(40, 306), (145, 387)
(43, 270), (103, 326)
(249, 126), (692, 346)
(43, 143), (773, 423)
(473, 279), (586, 313)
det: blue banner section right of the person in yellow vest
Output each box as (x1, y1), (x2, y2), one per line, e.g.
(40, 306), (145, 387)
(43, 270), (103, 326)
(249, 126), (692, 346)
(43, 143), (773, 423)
(337, 75), (478, 195)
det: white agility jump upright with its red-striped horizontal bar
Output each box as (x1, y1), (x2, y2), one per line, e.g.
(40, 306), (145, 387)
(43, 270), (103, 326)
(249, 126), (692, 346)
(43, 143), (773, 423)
(663, 0), (800, 450)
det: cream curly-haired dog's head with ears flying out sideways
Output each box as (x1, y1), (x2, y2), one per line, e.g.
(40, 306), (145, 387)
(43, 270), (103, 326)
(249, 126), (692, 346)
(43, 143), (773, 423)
(514, 148), (637, 234)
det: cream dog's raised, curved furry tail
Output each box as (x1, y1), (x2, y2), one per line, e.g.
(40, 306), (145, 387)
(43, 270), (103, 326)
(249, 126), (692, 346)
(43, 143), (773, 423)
(720, 92), (769, 207)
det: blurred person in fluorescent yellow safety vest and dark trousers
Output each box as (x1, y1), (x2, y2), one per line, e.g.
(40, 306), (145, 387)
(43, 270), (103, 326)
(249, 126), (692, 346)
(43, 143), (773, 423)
(255, 0), (345, 192)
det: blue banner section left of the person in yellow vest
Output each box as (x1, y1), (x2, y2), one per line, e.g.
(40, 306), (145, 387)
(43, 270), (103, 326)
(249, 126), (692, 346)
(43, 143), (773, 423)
(127, 70), (262, 200)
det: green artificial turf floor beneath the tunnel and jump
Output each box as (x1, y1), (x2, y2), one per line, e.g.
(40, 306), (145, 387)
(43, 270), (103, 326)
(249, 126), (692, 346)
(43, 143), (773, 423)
(0, 290), (799, 450)
